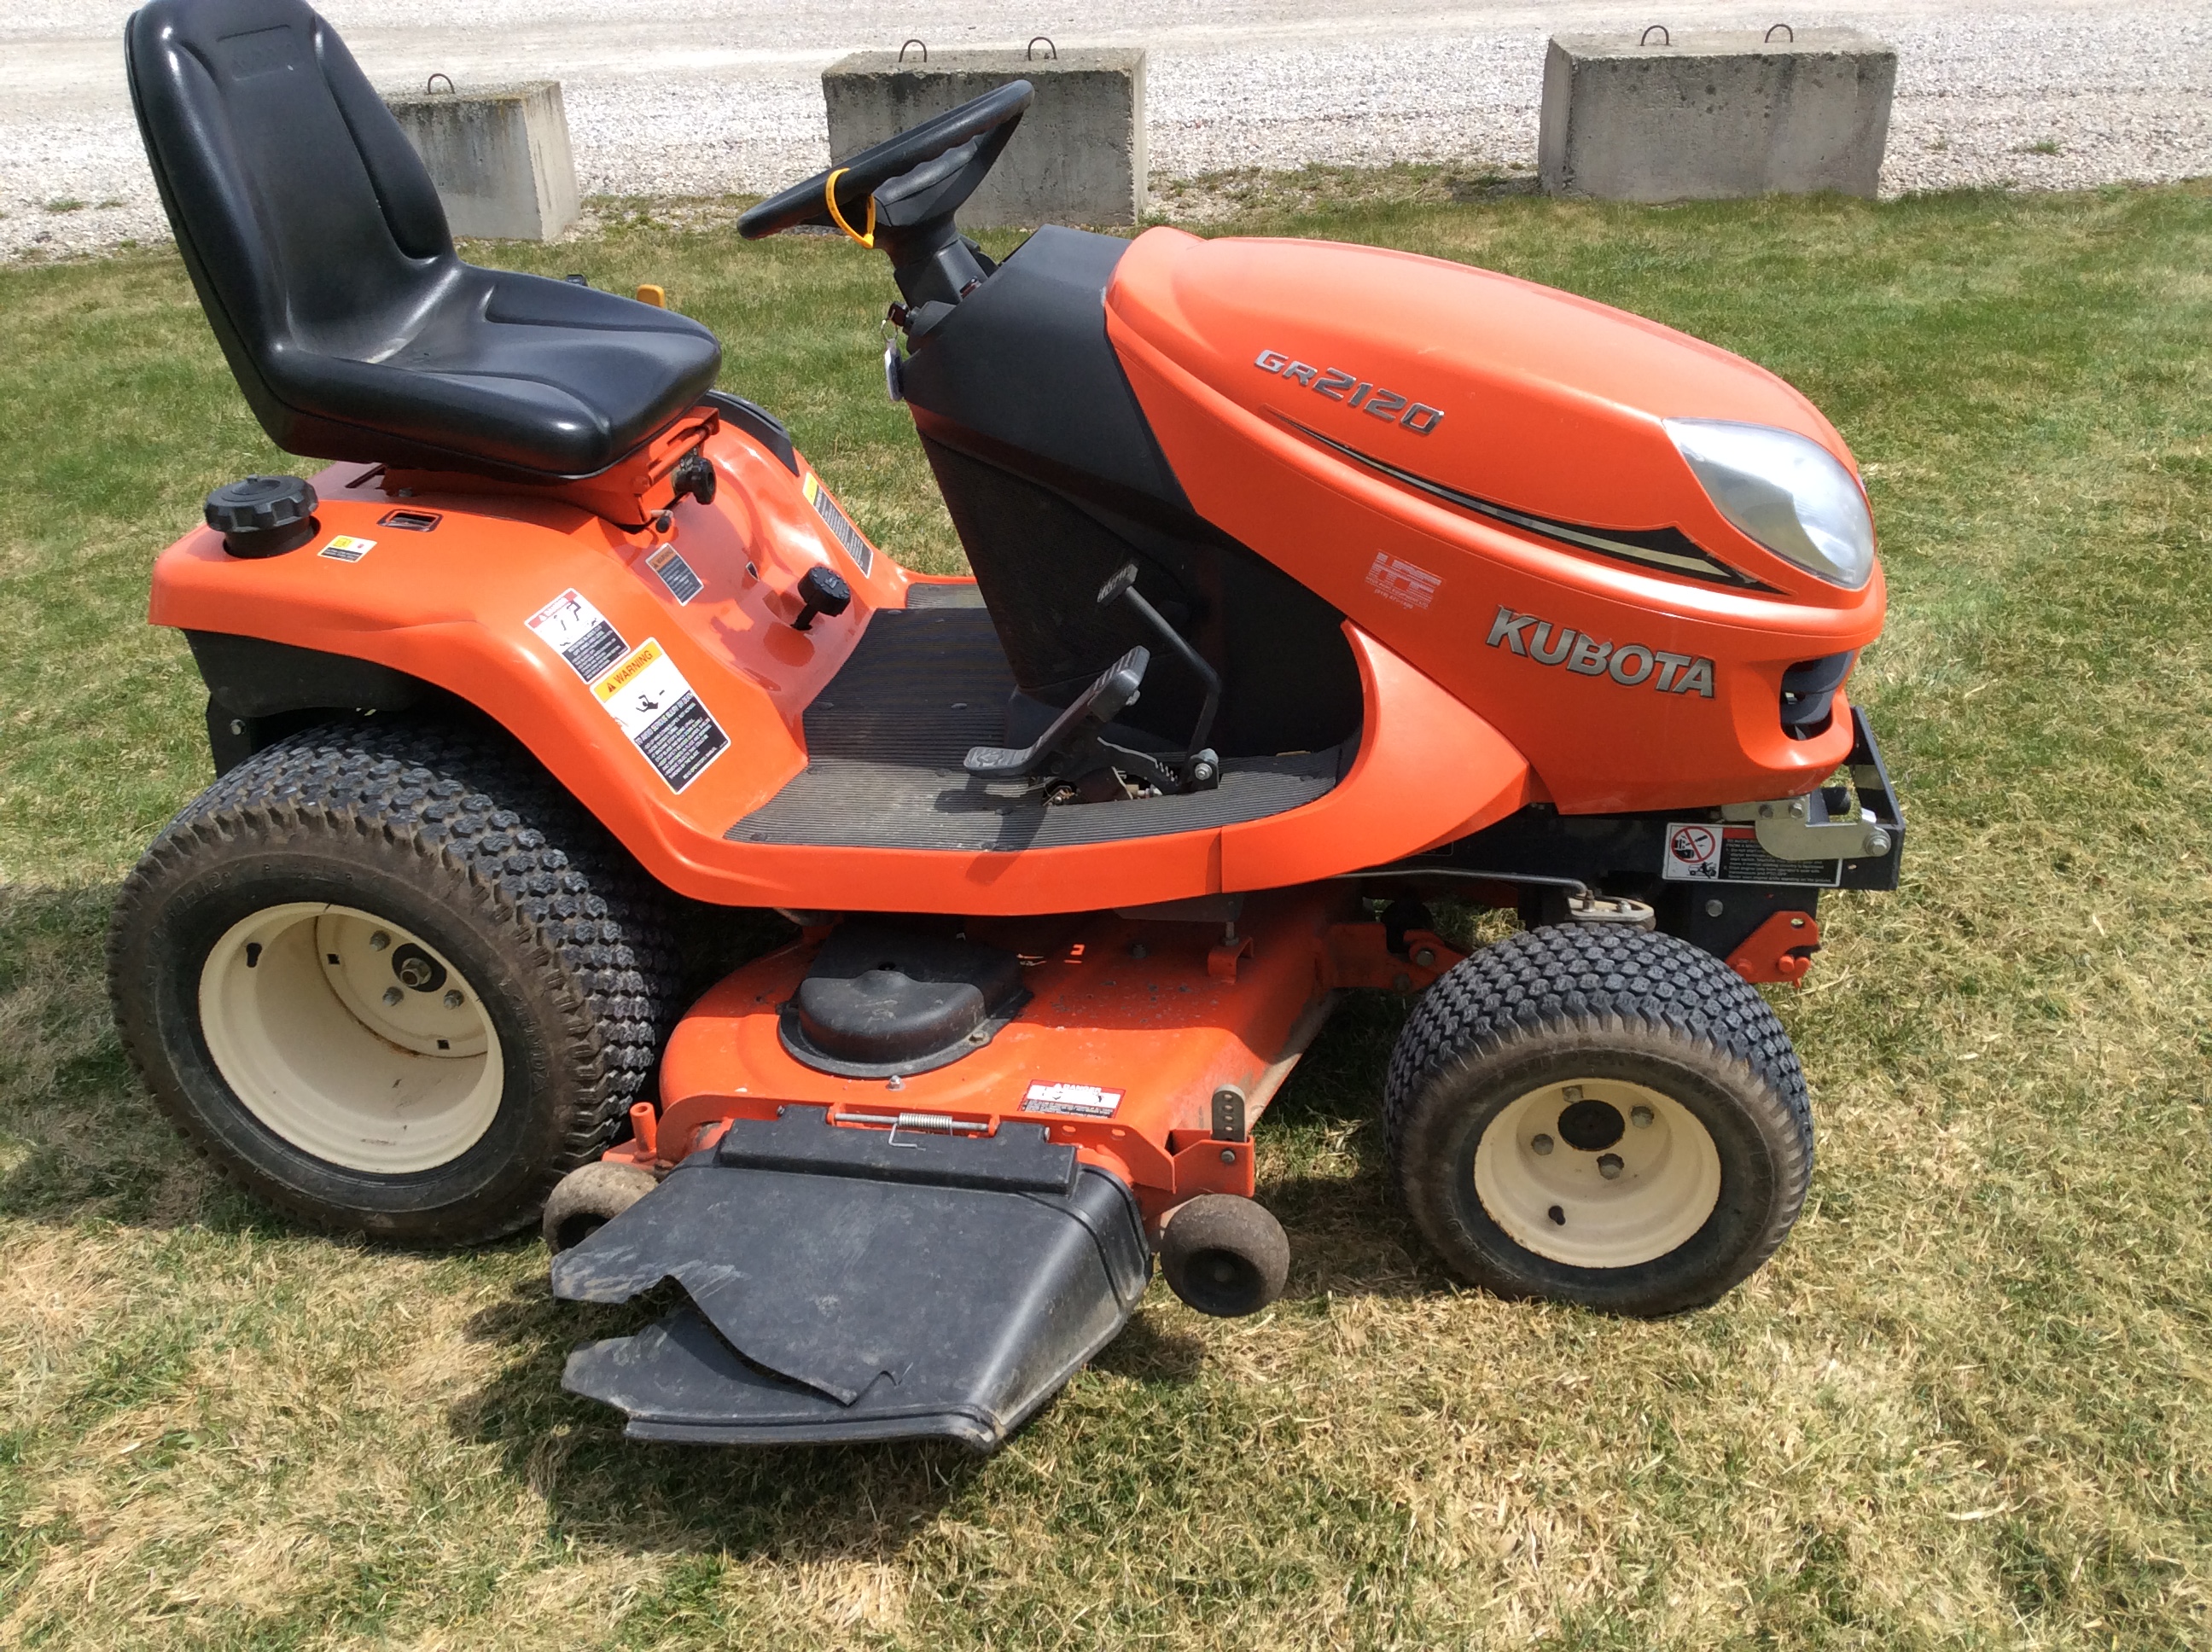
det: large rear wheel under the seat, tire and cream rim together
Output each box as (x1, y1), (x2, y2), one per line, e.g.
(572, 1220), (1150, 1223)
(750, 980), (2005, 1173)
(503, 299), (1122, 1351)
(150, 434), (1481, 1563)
(108, 718), (675, 1243)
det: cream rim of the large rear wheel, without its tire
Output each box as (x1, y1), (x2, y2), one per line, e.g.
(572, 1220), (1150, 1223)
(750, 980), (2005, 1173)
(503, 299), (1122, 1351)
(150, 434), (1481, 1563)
(199, 900), (504, 1177)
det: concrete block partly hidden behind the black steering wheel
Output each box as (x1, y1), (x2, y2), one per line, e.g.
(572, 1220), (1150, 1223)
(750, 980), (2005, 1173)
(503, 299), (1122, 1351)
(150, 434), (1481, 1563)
(823, 49), (1148, 228)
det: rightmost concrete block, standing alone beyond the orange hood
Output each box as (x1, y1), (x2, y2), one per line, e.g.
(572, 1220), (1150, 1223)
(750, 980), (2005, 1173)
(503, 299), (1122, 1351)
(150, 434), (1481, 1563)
(1537, 29), (1898, 201)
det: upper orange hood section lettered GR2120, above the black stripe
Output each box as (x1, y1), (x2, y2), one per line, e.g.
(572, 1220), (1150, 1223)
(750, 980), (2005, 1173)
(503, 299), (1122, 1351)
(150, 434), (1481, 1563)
(1109, 230), (1856, 604)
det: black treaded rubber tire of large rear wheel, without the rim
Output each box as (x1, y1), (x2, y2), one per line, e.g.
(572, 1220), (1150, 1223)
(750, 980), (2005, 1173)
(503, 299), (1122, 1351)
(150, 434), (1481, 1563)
(108, 717), (679, 1245)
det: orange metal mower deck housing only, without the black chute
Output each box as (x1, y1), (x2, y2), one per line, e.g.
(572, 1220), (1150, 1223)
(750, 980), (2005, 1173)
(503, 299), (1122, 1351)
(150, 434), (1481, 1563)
(632, 885), (1458, 1216)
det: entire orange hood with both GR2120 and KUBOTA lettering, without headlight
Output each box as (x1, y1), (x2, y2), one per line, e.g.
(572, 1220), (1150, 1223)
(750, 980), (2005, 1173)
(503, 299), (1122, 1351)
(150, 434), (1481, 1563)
(1106, 230), (1884, 814)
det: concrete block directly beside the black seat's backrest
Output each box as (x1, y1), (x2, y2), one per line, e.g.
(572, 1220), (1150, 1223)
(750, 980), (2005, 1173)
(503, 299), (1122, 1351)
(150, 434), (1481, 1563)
(385, 79), (578, 241)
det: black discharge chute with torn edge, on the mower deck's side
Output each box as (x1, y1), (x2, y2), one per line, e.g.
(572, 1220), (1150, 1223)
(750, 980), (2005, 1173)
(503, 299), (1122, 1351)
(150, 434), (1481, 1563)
(553, 1108), (1152, 1451)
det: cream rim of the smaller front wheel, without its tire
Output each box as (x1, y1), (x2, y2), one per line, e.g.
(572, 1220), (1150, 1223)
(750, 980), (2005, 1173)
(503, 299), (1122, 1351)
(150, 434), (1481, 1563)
(1476, 1079), (1721, 1267)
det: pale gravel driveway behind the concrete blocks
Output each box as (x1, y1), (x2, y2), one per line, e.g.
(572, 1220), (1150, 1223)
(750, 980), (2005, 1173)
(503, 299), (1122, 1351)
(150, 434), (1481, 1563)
(0, 0), (2212, 257)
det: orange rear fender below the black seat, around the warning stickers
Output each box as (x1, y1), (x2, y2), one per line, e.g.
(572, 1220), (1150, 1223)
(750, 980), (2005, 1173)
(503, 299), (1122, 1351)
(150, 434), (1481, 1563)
(150, 420), (907, 905)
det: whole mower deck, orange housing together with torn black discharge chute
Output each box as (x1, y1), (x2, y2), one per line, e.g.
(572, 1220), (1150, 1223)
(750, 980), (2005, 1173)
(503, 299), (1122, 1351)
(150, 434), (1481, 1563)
(553, 885), (1460, 1449)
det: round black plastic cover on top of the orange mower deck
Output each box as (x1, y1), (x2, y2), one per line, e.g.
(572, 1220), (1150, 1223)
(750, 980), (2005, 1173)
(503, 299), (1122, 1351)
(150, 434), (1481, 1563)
(777, 922), (1028, 1079)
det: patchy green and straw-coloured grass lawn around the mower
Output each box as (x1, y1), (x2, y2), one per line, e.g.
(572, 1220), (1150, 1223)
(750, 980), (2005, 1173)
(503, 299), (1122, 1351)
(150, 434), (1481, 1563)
(0, 179), (2212, 1652)
